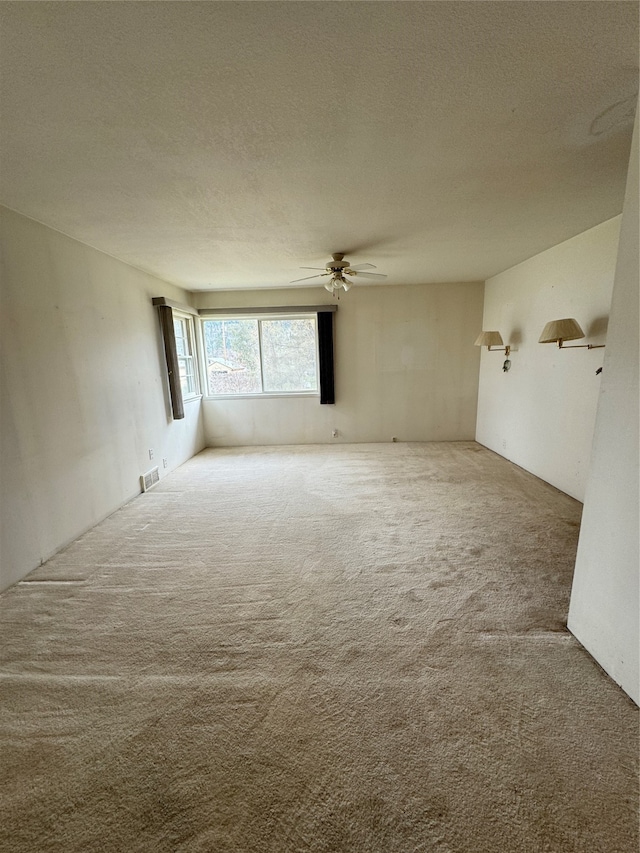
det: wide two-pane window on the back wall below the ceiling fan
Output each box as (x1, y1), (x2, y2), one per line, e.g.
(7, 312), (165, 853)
(202, 315), (318, 396)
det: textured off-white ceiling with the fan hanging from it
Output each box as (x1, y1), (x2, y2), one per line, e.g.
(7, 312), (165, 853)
(0, 0), (638, 290)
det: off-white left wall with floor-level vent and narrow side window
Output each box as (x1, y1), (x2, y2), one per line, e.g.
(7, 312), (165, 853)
(0, 208), (204, 588)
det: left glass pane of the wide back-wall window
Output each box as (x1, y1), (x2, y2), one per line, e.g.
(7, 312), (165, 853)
(203, 320), (262, 394)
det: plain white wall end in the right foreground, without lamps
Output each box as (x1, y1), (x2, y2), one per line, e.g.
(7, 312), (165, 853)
(568, 108), (640, 703)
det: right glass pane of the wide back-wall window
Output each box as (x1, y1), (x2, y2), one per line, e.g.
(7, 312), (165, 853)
(261, 318), (318, 391)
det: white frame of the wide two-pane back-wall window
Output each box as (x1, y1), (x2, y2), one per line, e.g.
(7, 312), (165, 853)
(198, 309), (320, 400)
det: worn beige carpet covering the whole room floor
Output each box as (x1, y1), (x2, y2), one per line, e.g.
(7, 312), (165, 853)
(0, 442), (638, 853)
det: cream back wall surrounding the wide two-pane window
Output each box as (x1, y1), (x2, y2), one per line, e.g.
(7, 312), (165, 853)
(194, 282), (483, 446)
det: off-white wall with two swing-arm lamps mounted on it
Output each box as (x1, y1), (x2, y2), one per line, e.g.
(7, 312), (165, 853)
(476, 217), (620, 500)
